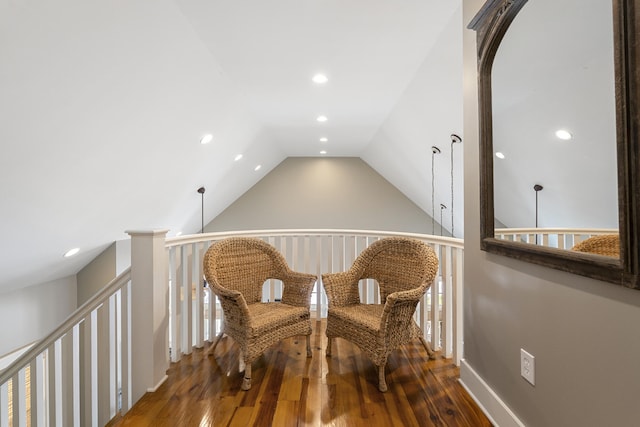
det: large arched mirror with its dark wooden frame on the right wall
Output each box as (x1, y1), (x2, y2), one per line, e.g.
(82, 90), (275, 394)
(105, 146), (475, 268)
(469, 0), (640, 289)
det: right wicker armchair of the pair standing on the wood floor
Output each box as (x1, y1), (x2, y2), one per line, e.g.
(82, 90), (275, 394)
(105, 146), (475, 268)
(322, 237), (438, 392)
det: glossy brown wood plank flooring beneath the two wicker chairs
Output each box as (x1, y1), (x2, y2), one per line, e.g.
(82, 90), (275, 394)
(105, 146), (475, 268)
(109, 321), (491, 427)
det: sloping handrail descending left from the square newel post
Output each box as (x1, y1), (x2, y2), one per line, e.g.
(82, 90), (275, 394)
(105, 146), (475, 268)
(0, 268), (131, 384)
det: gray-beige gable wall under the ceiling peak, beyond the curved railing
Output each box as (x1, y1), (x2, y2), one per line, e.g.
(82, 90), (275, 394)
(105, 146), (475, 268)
(205, 157), (446, 235)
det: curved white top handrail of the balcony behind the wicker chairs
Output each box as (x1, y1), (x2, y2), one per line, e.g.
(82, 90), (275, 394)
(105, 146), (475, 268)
(166, 229), (464, 249)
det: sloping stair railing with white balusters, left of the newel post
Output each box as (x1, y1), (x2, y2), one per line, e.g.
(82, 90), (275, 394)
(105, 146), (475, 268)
(0, 270), (131, 427)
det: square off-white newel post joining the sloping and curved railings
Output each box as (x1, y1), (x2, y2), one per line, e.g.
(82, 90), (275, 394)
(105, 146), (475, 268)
(127, 230), (169, 403)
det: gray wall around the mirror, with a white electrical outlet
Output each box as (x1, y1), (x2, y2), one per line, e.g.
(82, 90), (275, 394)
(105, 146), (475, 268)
(463, 0), (640, 427)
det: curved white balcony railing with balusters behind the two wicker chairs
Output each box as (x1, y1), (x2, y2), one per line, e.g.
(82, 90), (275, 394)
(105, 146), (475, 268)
(166, 230), (464, 364)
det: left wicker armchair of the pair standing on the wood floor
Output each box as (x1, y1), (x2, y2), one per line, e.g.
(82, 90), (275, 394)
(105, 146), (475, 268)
(204, 237), (317, 390)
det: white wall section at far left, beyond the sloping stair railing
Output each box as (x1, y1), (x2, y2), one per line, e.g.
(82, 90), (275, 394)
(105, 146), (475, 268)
(0, 276), (76, 356)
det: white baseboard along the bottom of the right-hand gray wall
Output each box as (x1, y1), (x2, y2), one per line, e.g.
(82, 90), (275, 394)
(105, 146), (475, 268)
(460, 359), (525, 427)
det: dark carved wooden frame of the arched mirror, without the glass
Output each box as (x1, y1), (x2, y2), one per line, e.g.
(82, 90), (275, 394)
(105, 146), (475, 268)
(468, 0), (640, 289)
